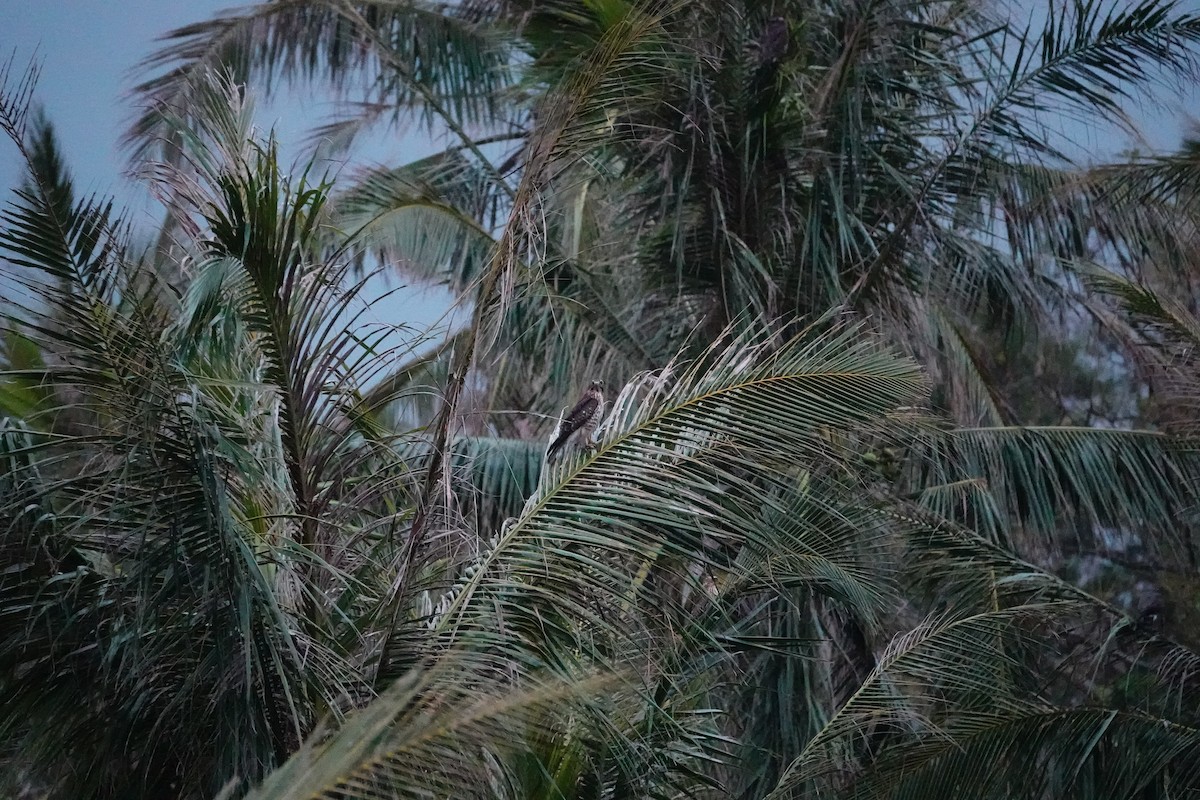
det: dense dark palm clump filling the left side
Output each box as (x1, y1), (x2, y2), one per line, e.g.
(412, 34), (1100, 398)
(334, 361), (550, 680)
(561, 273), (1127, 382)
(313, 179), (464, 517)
(0, 71), (432, 798)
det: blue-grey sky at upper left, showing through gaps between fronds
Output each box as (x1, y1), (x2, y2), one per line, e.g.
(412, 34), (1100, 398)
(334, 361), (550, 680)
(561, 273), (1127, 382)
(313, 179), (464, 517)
(0, 0), (449, 327)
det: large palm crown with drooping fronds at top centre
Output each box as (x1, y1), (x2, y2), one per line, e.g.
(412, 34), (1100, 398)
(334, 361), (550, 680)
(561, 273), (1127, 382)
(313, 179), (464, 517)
(124, 2), (1196, 424)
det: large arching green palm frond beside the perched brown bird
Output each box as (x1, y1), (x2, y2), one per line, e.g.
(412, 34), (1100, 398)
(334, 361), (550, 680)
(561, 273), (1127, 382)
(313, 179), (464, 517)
(443, 321), (922, 661)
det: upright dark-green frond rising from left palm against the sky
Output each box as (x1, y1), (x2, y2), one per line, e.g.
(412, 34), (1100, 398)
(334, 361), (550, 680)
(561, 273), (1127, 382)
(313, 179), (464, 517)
(152, 71), (427, 547)
